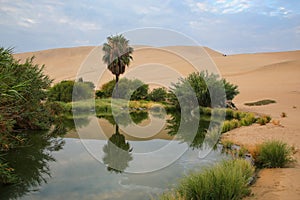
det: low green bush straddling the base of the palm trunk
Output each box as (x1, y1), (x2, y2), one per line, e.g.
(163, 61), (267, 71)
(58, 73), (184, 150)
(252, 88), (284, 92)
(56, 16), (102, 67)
(96, 78), (149, 100)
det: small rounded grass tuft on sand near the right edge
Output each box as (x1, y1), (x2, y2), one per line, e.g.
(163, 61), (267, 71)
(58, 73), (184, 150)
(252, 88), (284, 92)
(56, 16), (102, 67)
(256, 140), (295, 168)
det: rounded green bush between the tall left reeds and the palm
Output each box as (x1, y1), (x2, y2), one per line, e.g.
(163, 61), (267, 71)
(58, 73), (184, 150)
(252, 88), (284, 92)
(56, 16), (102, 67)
(48, 80), (95, 102)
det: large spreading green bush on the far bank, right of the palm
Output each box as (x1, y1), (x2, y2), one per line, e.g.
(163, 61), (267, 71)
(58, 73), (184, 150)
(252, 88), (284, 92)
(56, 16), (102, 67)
(170, 71), (239, 108)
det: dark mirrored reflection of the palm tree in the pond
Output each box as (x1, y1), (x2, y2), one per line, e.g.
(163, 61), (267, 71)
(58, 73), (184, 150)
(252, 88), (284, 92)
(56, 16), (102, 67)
(103, 125), (132, 173)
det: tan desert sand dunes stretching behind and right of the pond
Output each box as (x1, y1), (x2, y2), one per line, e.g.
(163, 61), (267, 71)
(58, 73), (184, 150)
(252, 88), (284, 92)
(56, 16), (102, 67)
(15, 46), (300, 200)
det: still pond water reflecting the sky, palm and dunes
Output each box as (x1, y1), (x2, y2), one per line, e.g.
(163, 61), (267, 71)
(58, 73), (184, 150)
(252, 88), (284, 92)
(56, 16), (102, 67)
(0, 113), (226, 200)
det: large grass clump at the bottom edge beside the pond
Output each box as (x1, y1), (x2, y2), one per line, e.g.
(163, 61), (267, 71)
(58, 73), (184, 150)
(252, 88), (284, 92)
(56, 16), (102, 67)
(160, 159), (254, 200)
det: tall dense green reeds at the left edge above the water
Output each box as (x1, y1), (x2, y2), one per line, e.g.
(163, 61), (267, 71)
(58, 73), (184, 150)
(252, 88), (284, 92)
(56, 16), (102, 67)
(0, 48), (53, 141)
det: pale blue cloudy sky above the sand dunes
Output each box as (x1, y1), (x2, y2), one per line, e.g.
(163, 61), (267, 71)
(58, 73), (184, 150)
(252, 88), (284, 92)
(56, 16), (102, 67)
(0, 0), (300, 54)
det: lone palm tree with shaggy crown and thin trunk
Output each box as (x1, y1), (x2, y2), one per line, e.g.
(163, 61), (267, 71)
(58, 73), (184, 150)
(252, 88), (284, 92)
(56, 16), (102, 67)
(102, 34), (133, 95)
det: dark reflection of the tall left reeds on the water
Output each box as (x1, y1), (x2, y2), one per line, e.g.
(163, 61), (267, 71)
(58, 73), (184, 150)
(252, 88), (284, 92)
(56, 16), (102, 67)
(0, 132), (65, 199)
